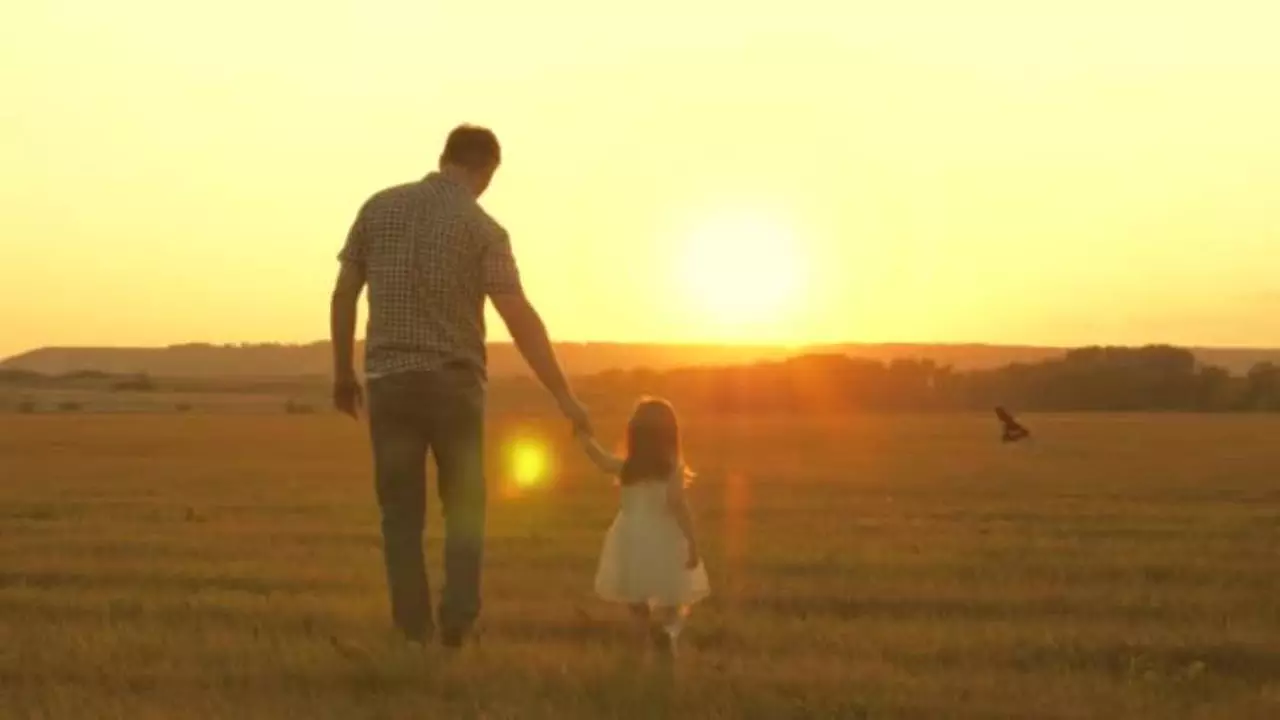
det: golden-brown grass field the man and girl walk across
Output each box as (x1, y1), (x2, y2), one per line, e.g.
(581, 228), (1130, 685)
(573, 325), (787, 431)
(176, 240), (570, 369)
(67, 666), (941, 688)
(0, 414), (1280, 720)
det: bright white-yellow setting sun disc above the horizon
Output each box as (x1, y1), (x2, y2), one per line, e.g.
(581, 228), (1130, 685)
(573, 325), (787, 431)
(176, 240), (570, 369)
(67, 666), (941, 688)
(681, 211), (804, 332)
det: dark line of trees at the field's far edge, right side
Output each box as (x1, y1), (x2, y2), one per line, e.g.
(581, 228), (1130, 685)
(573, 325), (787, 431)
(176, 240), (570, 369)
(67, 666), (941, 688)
(576, 345), (1280, 413)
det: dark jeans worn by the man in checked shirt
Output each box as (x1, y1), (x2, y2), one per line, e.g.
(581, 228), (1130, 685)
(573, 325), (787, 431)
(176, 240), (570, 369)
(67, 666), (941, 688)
(369, 368), (486, 641)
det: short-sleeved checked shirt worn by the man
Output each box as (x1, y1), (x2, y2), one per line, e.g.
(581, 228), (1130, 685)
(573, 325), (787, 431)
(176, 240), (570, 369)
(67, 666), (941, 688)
(338, 173), (521, 378)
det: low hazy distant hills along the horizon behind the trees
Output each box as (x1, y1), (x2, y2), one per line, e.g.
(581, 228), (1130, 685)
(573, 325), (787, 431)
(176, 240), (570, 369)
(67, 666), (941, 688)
(0, 342), (1280, 378)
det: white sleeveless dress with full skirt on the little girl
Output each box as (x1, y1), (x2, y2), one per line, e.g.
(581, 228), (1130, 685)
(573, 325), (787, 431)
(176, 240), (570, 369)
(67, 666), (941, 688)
(595, 480), (710, 607)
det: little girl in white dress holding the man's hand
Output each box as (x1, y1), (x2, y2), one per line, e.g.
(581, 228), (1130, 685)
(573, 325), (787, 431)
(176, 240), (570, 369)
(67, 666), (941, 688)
(580, 398), (710, 655)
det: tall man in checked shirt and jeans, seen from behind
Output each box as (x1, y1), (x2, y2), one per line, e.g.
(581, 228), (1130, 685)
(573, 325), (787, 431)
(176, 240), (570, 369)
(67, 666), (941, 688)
(330, 126), (590, 647)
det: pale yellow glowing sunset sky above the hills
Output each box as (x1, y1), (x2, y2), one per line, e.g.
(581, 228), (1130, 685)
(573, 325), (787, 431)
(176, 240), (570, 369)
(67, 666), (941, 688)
(0, 0), (1280, 355)
